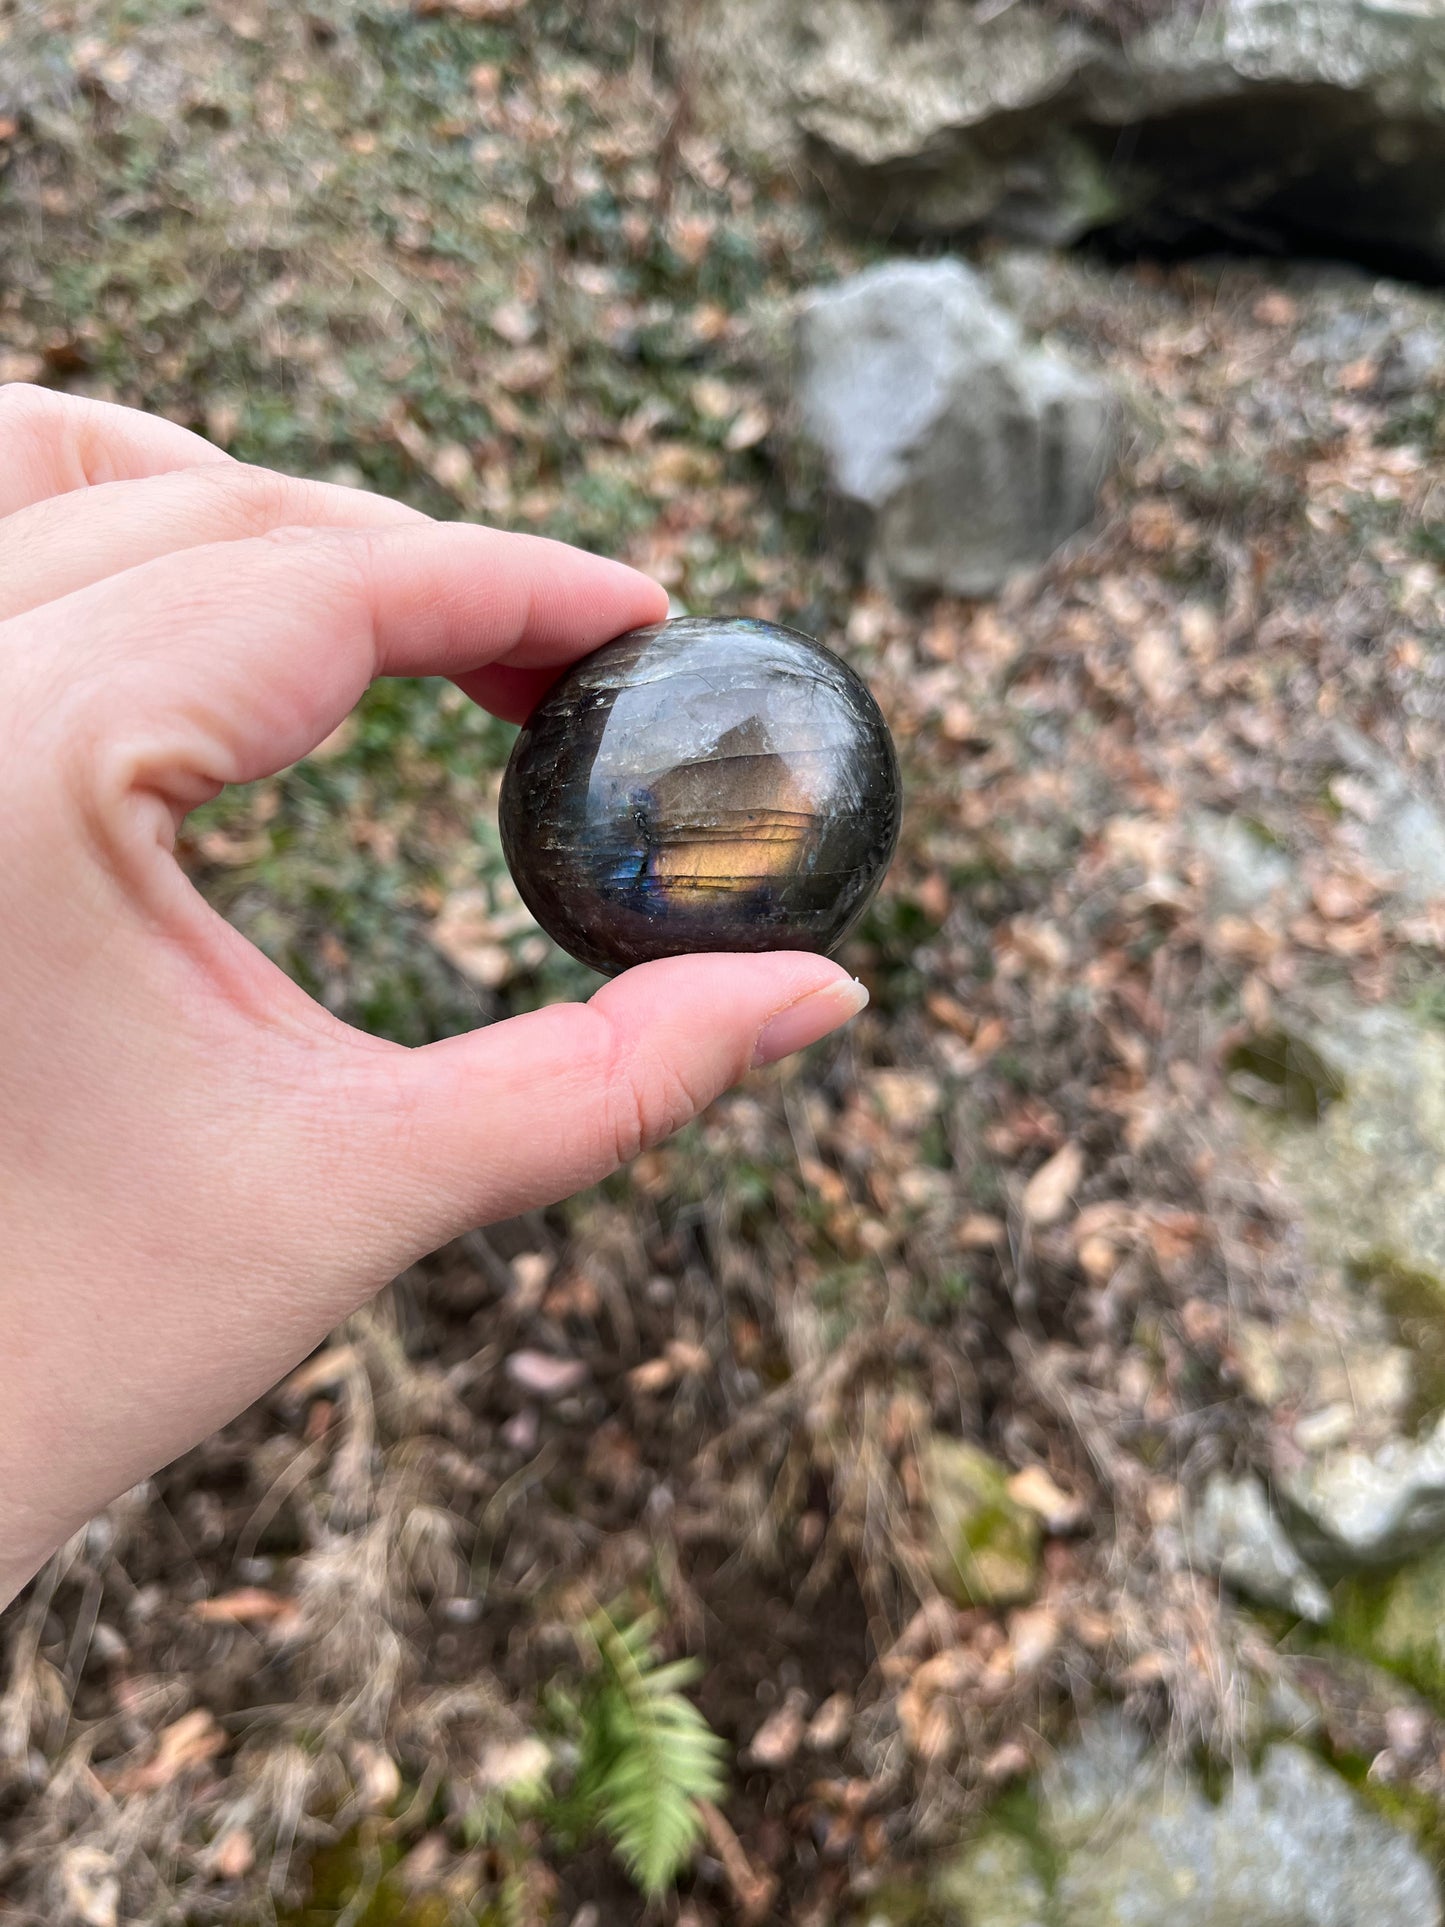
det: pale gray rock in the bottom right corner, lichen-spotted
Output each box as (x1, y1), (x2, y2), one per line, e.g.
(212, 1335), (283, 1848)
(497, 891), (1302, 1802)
(936, 1721), (1441, 1927)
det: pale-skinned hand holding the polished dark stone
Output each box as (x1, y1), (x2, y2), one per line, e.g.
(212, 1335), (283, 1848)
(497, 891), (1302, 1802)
(0, 385), (865, 1605)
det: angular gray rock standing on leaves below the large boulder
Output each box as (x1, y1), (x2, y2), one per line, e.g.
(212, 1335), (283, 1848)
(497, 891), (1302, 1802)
(796, 260), (1116, 595)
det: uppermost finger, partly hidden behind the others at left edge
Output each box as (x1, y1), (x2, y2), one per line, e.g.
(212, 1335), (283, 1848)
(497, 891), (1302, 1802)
(0, 382), (231, 516)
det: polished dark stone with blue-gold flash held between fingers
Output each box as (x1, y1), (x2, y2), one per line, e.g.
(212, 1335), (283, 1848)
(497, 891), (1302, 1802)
(501, 617), (902, 975)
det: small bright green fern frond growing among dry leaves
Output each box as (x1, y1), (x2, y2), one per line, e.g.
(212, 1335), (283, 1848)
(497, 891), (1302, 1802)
(578, 1613), (726, 1898)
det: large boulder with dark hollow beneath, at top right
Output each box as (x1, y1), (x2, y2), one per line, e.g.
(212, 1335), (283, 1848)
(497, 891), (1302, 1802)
(678, 0), (1445, 268)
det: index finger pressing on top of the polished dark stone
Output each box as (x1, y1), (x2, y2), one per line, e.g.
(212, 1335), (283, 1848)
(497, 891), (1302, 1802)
(19, 522), (667, 793)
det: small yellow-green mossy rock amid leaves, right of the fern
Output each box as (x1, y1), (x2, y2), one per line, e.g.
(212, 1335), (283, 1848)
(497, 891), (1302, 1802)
(919, 1438), (1040, 1605)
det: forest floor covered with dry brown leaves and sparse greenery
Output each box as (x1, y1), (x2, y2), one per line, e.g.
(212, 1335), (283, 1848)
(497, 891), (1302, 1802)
(0, 0), (1445, 1927)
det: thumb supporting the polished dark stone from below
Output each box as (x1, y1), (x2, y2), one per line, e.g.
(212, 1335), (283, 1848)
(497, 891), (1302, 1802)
(353, 950), (867, 1262)
